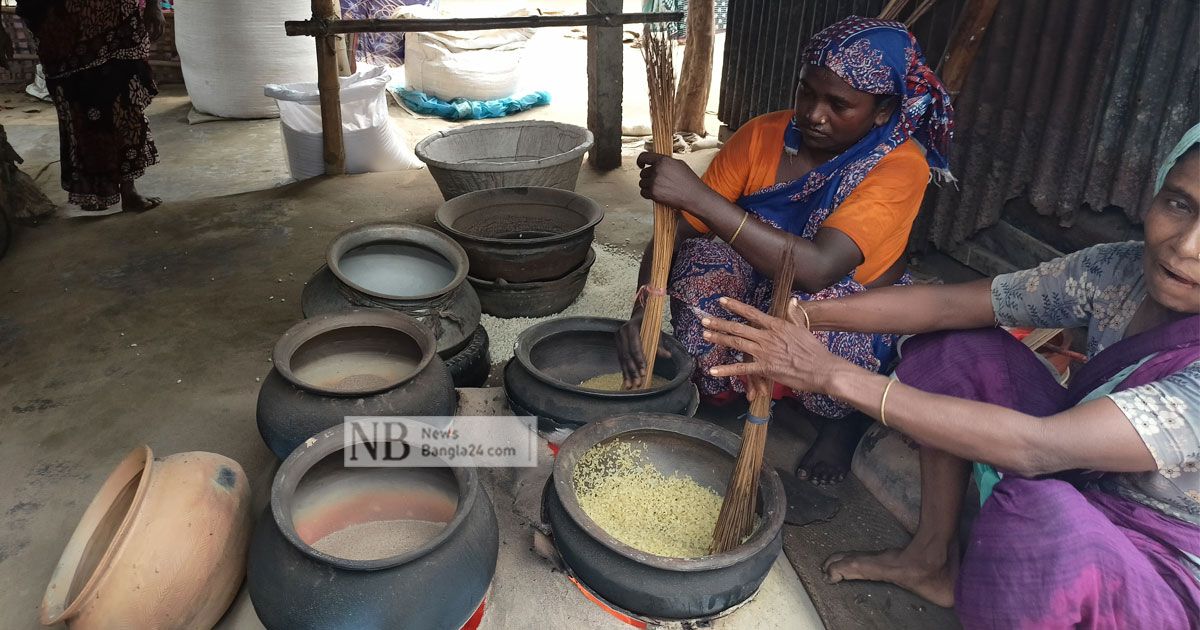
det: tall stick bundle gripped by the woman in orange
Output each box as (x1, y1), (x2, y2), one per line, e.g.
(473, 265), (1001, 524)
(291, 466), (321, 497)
(641, 24), (679, 389)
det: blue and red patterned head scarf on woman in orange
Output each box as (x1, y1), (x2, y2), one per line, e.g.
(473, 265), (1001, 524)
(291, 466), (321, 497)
(785, 16), (954, 181)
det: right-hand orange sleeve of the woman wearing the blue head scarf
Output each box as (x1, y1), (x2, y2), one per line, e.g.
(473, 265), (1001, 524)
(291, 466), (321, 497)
(821, 140), (929, 284)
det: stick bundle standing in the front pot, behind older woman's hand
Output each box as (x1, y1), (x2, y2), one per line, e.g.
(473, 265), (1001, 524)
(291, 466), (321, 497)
(712, 250), (796, 553)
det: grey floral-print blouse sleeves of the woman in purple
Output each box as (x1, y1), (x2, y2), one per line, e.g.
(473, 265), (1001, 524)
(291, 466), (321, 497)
(991, 241), (1200, 523)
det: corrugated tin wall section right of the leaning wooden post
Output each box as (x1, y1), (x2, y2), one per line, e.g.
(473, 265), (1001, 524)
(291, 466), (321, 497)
(918, 0), (1200, 248)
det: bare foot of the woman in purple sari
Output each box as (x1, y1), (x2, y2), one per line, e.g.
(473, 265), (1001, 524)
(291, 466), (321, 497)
(822, 547), (959, 608)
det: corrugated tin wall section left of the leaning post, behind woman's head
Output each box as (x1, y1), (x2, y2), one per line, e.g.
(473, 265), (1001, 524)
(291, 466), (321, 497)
(718, 0), (964, 130)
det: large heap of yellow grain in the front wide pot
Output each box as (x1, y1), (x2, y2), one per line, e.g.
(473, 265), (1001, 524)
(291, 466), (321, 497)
(574, 442), (721, 558)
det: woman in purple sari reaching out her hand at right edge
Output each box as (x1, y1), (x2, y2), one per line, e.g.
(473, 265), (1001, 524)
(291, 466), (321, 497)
(704, 125), (1200, 629)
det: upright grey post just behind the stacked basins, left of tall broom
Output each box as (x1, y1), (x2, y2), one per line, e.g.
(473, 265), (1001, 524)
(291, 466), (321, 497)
(588, 0), (625, 170)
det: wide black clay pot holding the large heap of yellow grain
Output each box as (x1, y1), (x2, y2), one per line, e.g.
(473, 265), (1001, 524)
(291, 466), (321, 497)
(542, 414), (787, 619)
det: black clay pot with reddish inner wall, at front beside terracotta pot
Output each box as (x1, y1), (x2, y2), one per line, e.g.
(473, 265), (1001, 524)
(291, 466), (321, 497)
(246, 427), (499, 630)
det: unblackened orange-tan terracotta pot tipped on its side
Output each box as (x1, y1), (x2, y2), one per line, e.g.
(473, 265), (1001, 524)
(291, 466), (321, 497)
(41, 446), (251, 629)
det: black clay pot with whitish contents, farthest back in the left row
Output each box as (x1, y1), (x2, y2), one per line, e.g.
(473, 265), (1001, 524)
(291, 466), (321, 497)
(300, 223), (480, 359)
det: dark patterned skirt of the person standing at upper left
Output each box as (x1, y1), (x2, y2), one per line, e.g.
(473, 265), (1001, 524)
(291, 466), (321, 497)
(46, 59), (158, 209)
